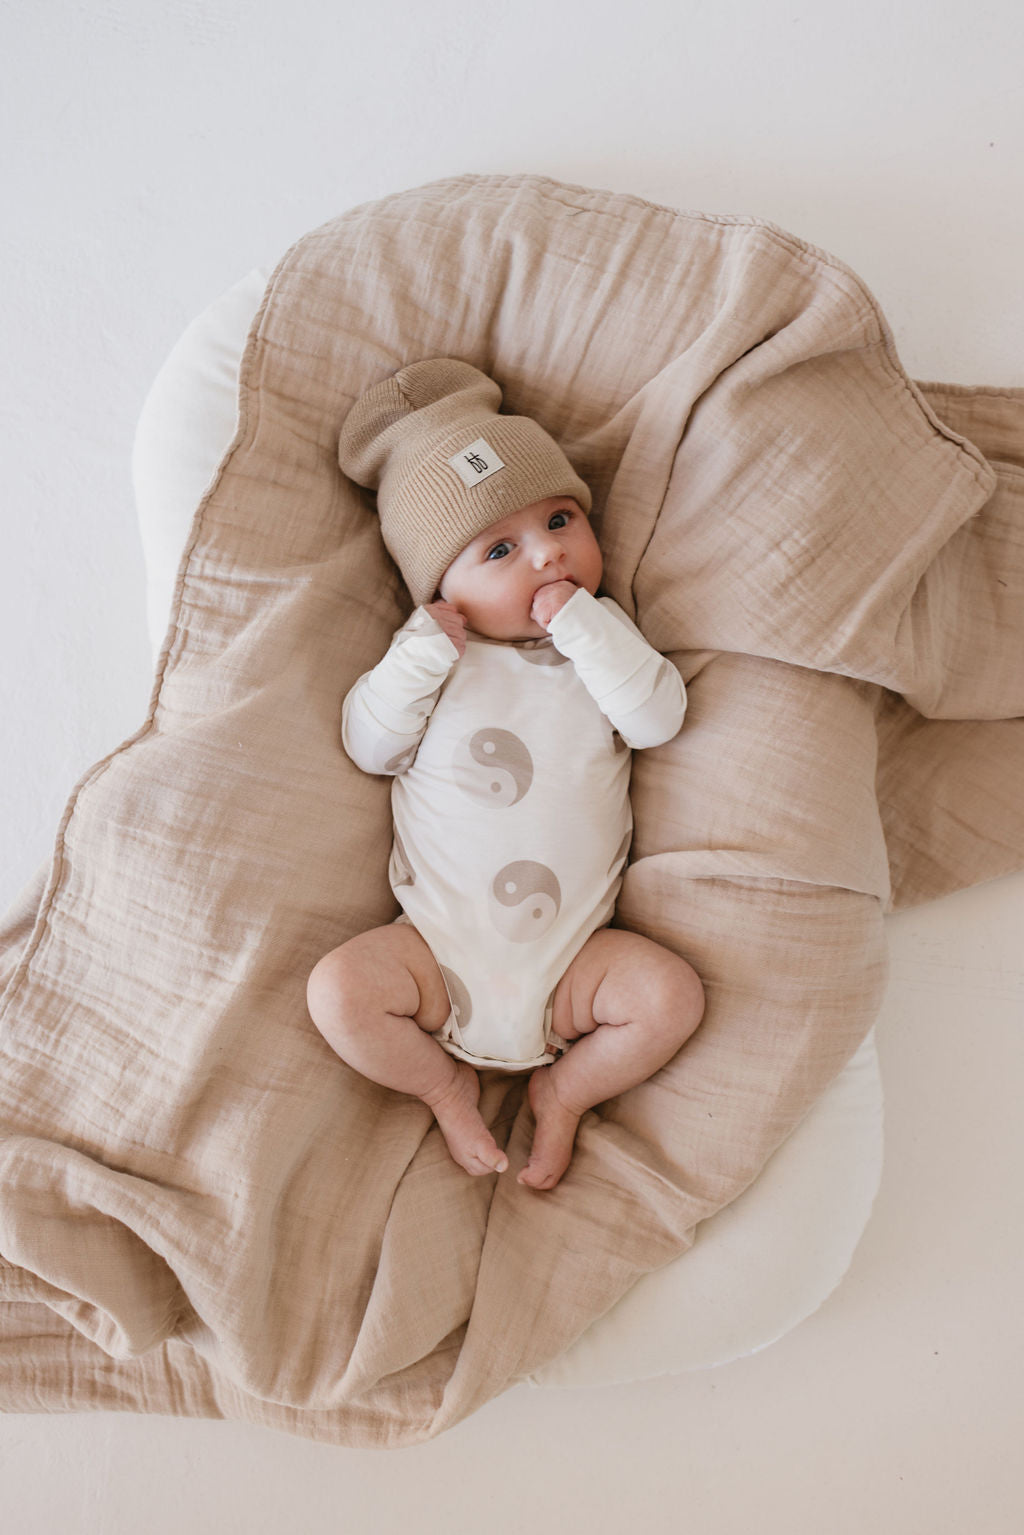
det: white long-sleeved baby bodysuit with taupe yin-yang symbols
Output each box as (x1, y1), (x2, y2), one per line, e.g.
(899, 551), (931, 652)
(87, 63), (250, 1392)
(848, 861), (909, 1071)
(342, 588), (686, 1070)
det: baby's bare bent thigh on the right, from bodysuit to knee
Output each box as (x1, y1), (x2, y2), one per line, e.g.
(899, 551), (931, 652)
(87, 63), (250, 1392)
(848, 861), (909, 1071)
(551, 927), (705, 1039)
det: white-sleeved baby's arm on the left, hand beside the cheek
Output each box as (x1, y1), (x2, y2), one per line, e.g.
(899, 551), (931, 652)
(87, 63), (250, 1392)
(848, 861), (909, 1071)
(341, 608), (461, 775)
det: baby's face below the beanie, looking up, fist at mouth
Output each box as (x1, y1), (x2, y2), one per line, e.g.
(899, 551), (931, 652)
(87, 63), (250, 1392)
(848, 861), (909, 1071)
(441, 496), (602, 640)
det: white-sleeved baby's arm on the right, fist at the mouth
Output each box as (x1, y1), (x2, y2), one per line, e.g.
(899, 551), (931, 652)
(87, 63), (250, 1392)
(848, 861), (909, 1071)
(548, 588), (686, 748)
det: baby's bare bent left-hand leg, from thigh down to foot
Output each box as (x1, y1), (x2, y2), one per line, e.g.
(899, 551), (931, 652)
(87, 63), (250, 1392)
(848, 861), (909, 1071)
(306, 923), (508, 1173)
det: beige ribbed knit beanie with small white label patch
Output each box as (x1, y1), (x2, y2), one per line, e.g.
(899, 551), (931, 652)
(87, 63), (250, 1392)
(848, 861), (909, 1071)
(338, 358), (591, 603)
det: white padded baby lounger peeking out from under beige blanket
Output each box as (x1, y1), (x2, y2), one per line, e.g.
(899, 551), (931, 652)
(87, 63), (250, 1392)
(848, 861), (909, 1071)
(134, 270), (883, 1386)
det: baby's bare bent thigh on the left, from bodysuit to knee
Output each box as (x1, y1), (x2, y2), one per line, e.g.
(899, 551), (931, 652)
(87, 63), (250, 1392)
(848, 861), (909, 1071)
(307, 923), (451, 1033)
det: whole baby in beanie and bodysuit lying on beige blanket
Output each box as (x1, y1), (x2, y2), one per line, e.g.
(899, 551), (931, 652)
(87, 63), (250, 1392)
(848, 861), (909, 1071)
(309, 358), (703, 1190)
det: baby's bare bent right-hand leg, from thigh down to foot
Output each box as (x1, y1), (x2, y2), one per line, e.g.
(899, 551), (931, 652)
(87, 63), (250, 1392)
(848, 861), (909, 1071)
(519, 927), (705, 1188)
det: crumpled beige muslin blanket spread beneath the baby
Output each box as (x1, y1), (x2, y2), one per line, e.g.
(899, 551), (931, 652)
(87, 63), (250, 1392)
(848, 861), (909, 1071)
(0, 175), (1024, 1446)
